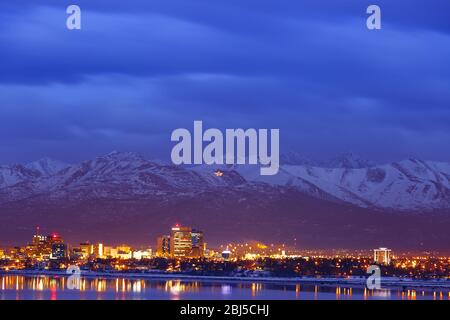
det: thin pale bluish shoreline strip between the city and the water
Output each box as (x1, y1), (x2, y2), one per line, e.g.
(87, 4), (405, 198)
(0, 270), (450, 291)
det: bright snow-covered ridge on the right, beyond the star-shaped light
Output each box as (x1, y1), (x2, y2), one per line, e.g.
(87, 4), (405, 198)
(239, 159), (450, 210)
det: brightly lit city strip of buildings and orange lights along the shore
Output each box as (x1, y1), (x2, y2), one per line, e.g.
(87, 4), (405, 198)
(0, 224), (450, 282)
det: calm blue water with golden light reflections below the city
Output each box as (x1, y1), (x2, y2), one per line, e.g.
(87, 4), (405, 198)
(0, 275), (450, 300)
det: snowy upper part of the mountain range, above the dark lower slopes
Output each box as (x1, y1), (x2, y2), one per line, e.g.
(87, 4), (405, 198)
(0, 152), (450, 211)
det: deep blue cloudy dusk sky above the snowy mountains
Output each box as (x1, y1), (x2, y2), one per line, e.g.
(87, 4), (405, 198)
(0, 0), (450, 163)
